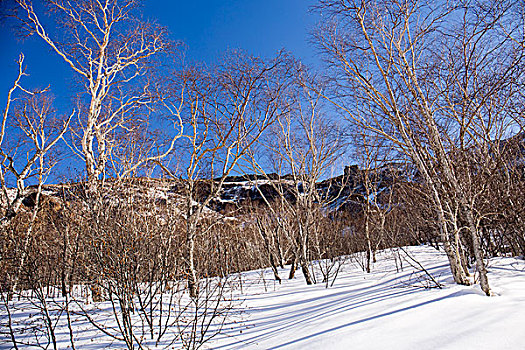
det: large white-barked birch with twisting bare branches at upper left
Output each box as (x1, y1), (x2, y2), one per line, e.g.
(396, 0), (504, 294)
(17, 0), (182, 187)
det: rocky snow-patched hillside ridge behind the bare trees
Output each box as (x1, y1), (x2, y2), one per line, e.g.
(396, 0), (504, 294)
(0, 163), (392, 221)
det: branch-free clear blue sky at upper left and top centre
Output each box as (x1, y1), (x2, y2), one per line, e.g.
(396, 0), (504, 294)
(0, 0), (316, 105)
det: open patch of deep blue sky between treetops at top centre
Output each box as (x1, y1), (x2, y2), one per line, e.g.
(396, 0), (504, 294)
(144, 0), (314, 61)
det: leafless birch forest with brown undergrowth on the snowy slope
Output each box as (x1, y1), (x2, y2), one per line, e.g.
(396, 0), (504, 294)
(0, 0), (525, 349)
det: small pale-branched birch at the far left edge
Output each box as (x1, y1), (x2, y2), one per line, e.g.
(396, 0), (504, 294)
(0, 54), (70, 305)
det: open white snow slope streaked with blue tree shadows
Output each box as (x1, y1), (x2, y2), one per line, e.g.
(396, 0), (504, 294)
(0, 246), (525, 350)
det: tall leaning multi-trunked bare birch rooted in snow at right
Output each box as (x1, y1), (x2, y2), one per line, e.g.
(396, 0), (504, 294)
(316, 0), (521, 295)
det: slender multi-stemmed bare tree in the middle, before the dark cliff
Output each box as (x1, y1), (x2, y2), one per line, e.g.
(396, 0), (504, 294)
(252, 68), (345, 284)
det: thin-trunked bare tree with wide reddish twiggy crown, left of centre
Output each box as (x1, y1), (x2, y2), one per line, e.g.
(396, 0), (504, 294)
(161, 52), (290, 297)
